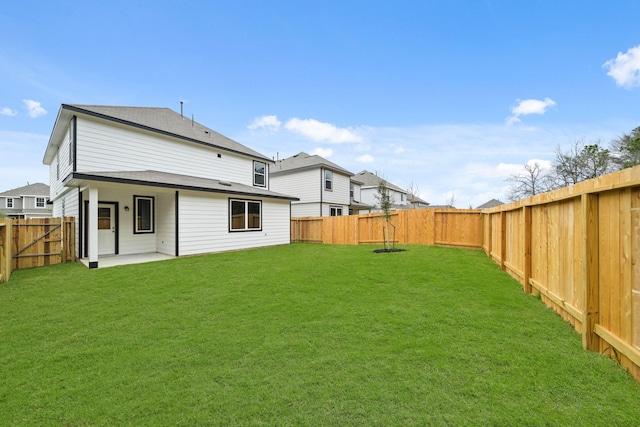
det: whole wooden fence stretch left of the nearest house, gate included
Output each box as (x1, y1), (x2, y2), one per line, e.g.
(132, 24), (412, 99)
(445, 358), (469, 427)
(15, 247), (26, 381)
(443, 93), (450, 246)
(0, 217), (75, 282)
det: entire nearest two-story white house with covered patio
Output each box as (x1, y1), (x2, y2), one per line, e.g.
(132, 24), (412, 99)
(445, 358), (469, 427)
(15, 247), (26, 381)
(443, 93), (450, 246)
(43, 104), (296, 268)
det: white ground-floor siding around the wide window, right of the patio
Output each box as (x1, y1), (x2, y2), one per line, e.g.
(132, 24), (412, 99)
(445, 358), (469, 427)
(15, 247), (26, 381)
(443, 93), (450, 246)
(179, 192), (290, 255)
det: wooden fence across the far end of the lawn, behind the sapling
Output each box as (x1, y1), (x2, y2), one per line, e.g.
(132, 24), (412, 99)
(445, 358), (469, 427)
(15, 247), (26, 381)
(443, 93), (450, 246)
(291, 209), (482, 249)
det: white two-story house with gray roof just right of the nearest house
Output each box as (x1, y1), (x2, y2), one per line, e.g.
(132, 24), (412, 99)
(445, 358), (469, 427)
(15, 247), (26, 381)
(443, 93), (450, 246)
(270, 152), (371, 217)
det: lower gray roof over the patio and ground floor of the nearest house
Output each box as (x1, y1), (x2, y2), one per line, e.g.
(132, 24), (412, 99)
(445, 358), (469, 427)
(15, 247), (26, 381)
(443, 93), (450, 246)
(64, 171), (299, 200)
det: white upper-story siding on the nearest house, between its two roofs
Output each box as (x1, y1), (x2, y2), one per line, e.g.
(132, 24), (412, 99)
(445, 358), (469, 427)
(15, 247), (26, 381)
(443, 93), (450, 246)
(76, 118), (260, 185)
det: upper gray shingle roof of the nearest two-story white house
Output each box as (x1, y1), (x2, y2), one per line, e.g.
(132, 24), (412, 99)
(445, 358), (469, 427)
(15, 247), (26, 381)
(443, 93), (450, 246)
(44, 104), (273, 164)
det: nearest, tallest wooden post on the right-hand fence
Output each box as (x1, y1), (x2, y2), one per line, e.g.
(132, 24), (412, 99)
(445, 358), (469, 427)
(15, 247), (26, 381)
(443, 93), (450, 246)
(581, 193), (600, 352)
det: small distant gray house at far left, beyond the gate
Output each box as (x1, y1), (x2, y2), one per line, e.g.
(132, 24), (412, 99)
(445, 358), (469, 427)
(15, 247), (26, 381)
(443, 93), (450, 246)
(0, 182), (51, 218)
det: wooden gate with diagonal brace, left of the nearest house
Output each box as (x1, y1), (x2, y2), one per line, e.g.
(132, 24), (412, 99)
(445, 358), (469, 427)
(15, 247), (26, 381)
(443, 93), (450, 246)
(11, 217), (75, 270)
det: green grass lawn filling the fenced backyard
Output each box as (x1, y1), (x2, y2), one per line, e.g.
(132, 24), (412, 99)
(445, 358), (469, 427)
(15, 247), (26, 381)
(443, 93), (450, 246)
(0, 244), (640, 426)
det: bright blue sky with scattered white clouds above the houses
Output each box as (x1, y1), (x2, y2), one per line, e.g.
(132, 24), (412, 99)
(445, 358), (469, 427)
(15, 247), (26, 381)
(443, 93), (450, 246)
(0, 0), (640, 208)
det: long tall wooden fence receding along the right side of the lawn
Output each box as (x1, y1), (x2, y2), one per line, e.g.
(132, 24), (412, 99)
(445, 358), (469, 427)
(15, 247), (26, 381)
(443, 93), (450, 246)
(482, 166), (640, 380)
